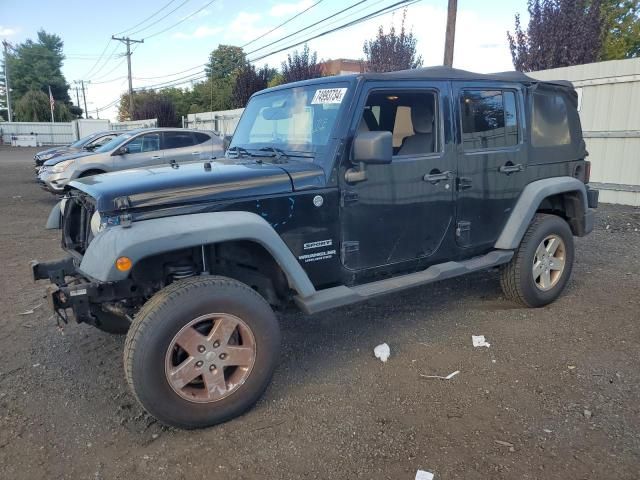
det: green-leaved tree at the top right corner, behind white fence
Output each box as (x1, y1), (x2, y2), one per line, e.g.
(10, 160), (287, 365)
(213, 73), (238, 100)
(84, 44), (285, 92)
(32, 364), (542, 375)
(600, 0), (640, 60)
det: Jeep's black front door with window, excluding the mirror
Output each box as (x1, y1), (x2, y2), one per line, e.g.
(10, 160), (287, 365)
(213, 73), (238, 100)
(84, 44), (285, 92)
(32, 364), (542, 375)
(340, 82), (455, 271)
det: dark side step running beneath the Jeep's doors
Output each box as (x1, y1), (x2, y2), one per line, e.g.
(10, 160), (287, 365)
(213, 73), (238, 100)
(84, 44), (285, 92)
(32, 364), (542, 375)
(294, 250), (513, 314)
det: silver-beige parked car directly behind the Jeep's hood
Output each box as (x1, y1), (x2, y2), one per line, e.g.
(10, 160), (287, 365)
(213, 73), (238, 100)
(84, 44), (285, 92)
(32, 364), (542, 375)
(38, 128), (224, 193)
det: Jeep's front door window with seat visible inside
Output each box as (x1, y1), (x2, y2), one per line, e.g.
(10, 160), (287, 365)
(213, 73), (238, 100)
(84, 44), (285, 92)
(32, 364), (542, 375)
(358, 91), (440, 155)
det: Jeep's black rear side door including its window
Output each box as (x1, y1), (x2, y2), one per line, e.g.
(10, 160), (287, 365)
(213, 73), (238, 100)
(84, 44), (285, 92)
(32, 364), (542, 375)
(453, 86), (527, 250)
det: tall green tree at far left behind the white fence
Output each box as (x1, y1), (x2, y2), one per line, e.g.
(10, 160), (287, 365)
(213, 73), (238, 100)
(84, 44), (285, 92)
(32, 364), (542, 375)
(7, 30), (71, 112)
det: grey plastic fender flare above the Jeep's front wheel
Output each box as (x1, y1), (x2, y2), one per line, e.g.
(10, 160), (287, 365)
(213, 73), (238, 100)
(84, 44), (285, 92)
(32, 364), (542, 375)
(78, 211), (315, 297)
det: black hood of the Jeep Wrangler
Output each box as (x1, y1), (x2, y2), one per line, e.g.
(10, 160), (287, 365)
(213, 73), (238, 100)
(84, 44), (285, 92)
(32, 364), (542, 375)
(69, 159), (304, 212)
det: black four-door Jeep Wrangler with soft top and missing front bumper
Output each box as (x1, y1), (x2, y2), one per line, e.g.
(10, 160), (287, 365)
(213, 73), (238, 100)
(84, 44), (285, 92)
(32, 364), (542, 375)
(33, 67), (598, 428)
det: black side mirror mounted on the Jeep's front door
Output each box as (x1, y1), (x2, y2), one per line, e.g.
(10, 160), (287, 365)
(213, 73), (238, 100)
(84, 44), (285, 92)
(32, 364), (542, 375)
(345, 131), (393, 183)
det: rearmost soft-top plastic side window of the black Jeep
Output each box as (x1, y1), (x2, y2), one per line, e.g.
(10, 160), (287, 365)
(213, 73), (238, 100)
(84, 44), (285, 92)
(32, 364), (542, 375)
(531, 92), (571, 147)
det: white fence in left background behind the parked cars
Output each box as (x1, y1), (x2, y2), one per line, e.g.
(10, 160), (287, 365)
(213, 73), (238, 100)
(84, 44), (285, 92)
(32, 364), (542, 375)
(0, 118), (158, 145)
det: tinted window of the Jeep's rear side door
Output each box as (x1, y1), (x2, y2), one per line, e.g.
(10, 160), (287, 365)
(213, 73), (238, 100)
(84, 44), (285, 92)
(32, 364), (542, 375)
(460, 90), (518, 150)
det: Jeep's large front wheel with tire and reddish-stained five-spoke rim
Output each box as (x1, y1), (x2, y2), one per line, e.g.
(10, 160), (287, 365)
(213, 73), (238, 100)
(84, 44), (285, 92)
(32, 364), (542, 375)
(124, 276), (280, 429)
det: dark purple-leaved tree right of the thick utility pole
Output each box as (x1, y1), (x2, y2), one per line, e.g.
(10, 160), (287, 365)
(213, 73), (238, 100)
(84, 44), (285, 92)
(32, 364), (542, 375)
(507, 0), (604, 72)
